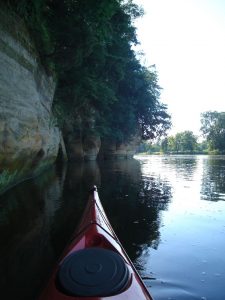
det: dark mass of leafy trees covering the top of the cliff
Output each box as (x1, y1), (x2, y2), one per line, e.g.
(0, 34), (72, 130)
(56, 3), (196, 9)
(4, 0), (170, 142)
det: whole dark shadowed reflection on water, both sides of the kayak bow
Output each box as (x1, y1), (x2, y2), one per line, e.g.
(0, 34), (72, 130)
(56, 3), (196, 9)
(0, 160), (171, 300)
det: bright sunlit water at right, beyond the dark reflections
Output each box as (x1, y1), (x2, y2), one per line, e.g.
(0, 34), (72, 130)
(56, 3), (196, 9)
(137, 156), (225, 300)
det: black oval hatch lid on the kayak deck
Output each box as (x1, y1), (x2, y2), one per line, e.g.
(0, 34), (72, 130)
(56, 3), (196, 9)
(57, 248), (129, 297)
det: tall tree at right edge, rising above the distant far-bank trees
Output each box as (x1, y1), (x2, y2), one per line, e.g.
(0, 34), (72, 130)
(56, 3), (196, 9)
(201, 111), (225, 153)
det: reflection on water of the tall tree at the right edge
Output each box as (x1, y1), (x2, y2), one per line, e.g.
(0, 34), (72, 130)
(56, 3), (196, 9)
(201, 157), (225, 201)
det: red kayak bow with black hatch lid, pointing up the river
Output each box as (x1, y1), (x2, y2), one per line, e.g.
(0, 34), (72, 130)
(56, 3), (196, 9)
(40, 187), (153, 300)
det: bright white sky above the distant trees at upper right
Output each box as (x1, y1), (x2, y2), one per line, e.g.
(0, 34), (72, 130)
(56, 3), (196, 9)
(134, 0), (225, 135)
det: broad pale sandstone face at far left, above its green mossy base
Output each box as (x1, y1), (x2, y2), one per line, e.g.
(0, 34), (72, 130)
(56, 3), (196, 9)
(0, 5), (60, 171)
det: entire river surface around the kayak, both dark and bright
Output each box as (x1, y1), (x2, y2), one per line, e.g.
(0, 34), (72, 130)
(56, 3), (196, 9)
(0, 156), (225, 300)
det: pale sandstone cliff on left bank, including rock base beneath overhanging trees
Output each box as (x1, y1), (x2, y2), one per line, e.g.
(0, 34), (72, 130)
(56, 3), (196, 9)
(0, 3), (139, 193)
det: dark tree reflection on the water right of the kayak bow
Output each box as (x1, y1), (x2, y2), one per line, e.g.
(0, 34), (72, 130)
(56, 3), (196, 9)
(99, 160), (171, 260)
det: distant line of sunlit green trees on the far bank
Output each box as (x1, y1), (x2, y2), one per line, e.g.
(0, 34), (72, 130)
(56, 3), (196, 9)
(138, 111), (225, 154)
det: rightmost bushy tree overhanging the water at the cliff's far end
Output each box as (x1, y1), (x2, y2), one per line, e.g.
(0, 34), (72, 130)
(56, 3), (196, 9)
(104, 63), (170, 141)
